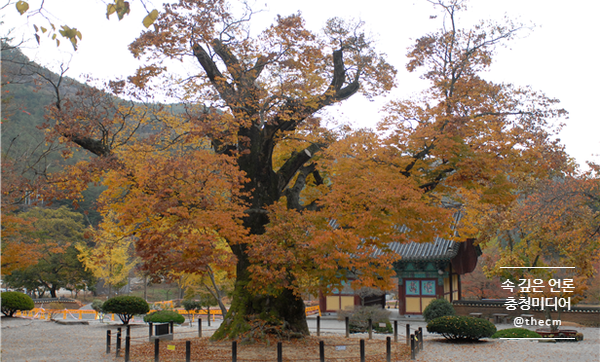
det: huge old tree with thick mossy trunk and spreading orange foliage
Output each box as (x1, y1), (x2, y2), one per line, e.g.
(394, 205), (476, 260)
(43, 0), (563, 338)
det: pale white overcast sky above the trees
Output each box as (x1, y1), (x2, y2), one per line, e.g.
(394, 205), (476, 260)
(2, 0), (600, 170)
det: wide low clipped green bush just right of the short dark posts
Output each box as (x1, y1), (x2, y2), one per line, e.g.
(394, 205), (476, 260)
(427, 316), (496, 341)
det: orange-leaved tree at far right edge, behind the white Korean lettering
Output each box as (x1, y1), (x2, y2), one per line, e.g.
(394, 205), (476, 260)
(482, 171), (600, 329)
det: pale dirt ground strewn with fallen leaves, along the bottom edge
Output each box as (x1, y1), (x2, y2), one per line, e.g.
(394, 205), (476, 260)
(0, 318), (600, 362)
